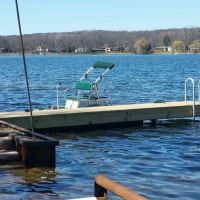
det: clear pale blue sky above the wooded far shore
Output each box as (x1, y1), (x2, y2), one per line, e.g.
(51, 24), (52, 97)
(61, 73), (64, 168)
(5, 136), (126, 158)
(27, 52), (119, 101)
(0, 0), (200, 36)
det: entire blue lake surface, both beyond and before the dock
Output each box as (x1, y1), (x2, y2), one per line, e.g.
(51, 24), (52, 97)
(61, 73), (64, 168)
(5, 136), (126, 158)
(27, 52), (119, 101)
(0, 55), (200, 200)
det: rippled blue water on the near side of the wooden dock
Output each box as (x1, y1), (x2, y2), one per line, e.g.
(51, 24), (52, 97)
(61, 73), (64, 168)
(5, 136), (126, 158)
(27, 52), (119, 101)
(0, 120), (200, 200)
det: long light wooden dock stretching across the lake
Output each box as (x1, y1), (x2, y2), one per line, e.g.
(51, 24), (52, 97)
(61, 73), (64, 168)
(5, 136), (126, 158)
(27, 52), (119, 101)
(0, 101), (200, 129)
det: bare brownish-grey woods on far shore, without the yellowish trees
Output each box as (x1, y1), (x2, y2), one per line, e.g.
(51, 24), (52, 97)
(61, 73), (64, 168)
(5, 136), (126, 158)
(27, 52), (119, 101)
(0, 28), (200, 52)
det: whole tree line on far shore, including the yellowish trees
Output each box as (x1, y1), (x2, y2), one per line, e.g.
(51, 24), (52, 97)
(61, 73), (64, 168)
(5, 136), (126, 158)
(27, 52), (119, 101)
(0, 27), (200, 53)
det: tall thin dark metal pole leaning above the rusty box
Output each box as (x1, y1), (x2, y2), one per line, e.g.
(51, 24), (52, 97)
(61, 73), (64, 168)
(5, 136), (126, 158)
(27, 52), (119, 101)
(15, 0), (35, 139)
